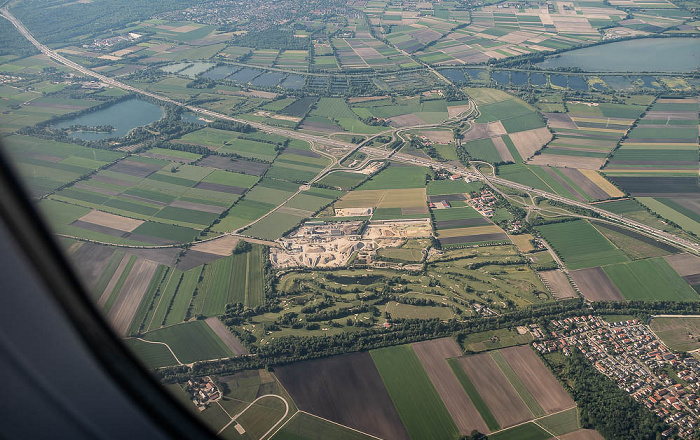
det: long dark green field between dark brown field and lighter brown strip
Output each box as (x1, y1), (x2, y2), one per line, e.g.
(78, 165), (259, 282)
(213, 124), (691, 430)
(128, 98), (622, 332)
(370, 345), (459, 440)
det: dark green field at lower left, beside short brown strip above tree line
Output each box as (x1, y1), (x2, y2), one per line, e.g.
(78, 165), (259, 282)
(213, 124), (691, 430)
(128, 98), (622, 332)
(144, 321), (233, 364)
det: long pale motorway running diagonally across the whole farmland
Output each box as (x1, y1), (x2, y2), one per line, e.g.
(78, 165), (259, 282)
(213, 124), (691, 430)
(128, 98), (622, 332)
(0, 8), (700, 254)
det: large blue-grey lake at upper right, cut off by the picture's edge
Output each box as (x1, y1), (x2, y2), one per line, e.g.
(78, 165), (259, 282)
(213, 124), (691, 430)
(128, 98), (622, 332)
(537, 38), (700, 72)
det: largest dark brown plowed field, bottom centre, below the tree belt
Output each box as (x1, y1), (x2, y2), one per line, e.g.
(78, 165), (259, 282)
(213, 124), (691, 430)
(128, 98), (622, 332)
(275, 352), (411, 440)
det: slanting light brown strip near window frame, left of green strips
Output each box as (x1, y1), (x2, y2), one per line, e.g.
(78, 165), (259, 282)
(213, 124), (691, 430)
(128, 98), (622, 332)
(107, 258), (158, 336)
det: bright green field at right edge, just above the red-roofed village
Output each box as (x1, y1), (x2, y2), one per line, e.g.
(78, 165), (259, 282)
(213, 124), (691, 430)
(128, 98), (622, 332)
(603, 257), (700, 301)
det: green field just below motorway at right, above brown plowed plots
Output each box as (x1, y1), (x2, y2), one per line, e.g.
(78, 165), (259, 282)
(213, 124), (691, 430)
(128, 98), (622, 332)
(536, 220), (629, 270)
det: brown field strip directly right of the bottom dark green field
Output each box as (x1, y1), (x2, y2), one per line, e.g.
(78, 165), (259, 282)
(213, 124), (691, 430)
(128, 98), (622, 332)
(412, 338), (489, 434)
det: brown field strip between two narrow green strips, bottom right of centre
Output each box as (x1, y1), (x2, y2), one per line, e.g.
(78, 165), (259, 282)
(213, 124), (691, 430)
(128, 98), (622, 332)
(459, 353), (532, 428)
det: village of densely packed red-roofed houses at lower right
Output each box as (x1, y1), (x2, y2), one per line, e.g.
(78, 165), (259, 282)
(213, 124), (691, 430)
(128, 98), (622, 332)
(533, 315), (700, 438)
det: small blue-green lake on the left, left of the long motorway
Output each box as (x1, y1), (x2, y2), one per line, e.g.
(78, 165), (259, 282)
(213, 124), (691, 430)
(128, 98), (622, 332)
(55, 98), (165, 141)
